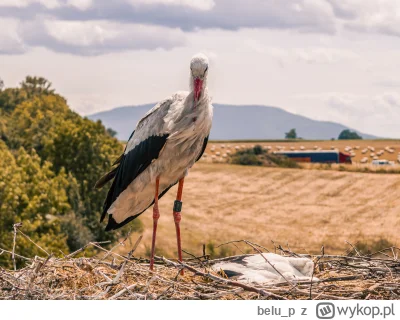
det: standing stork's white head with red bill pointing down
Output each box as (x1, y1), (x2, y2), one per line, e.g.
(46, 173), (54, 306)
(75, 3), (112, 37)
(190, 53), (208, 101)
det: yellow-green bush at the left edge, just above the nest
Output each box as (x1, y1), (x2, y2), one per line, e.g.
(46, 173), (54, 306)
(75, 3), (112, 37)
(0, 141), (71, 265)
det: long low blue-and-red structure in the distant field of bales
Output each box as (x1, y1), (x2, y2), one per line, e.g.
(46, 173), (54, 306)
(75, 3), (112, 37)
(274, 150), (351, 163)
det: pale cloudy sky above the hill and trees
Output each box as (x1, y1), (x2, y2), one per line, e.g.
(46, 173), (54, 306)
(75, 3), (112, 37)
(0, 0), (400, 138)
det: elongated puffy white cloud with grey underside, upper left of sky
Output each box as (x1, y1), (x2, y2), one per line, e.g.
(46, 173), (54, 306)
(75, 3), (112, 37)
(9, 17), (186, 55)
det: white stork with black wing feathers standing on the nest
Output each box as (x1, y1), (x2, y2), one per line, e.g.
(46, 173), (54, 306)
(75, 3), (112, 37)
(96, 54), (213, 270)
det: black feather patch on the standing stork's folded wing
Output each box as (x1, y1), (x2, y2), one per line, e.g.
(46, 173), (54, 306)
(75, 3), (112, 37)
(100, 134), (168, 221)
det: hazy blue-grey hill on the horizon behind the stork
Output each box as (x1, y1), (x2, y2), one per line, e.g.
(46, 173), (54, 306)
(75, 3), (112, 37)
(88, 104), (377, 140)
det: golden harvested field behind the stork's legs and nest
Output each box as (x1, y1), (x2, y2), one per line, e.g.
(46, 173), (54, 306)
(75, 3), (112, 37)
(125, 162), (400, 257)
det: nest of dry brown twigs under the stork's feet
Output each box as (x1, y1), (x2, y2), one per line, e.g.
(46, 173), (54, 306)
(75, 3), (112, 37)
(0, 232), (400, 300)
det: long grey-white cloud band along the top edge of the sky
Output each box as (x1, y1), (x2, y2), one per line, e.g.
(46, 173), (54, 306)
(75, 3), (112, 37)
(0, 0), (400, 41)
